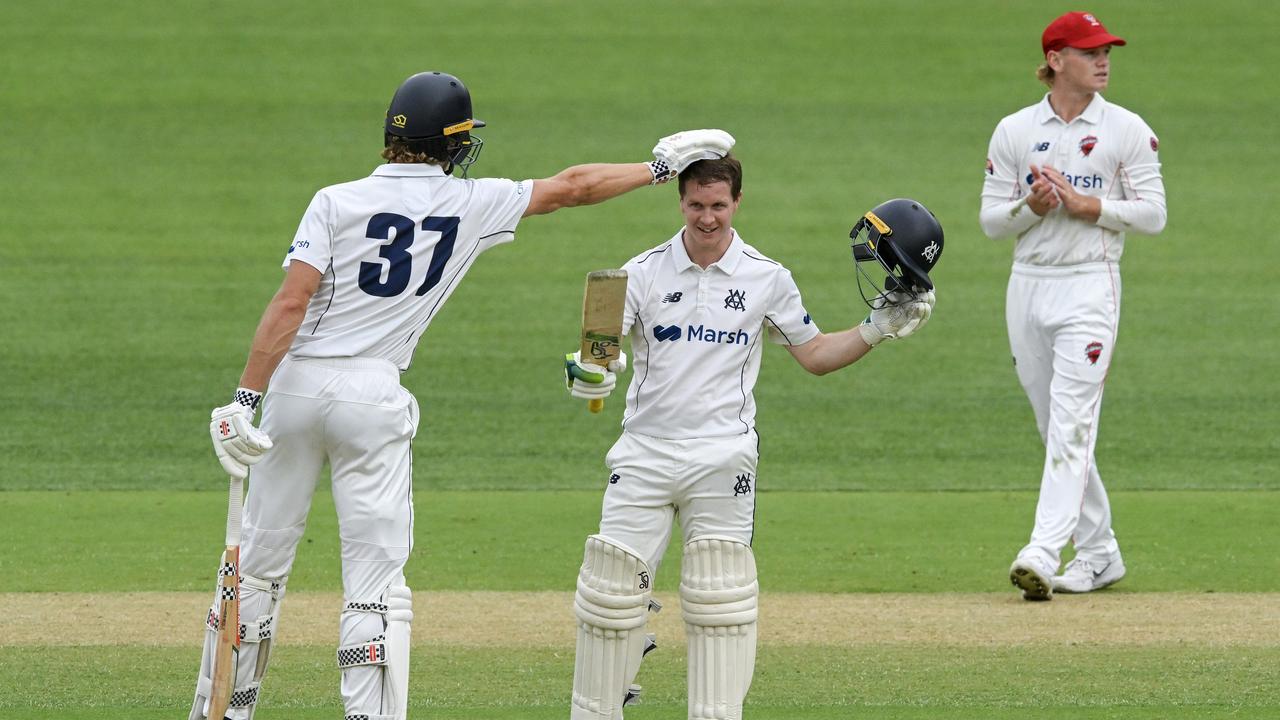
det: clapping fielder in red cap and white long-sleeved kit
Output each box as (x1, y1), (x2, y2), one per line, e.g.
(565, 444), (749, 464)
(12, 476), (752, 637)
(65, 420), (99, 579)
(979, 13), (1166, 600)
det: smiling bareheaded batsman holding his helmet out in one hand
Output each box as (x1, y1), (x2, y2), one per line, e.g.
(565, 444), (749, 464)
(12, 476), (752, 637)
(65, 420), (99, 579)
(567, 156), (942, 720)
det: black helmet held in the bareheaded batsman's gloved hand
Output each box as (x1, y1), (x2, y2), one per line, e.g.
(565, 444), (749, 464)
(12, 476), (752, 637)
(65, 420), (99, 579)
(849, 197), (942, 307)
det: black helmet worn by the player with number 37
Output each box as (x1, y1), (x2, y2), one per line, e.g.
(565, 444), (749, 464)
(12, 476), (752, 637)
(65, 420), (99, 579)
(383, 72), (484, 177)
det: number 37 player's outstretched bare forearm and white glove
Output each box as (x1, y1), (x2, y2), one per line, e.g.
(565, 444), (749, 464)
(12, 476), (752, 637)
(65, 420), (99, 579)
(525, 129), (733, 217)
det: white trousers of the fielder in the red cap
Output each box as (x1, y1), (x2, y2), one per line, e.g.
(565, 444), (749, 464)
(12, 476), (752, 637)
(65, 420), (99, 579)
(1005, 263), (1120, 568)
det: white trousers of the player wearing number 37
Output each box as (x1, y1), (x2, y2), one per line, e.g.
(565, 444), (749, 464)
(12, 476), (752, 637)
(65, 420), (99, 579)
(241, 357), (419, 715)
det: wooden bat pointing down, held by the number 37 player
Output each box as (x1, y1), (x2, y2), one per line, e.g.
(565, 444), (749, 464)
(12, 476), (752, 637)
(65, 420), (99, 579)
(207, 478), (244, 720)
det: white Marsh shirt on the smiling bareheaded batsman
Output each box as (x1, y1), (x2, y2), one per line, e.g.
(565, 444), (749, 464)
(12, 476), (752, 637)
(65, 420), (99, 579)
(622, 231), (818, 439)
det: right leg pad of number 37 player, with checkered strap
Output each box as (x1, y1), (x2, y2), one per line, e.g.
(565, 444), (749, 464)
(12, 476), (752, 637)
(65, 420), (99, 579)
(338, 584), (413, 720)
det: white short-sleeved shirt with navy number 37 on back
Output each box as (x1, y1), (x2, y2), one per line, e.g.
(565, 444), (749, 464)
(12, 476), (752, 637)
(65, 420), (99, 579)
(284, 163), (534, 370)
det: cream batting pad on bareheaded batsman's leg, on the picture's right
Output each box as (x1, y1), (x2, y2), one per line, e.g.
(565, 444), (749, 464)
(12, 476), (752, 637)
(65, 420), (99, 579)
(680, 536), (760, 720)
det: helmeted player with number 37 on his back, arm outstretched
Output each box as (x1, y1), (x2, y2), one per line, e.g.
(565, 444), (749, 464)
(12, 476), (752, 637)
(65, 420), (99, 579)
(191, 73), (733, 720)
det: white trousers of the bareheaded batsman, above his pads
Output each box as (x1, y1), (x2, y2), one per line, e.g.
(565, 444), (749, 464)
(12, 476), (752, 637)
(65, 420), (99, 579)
(600, 430), (760, 575)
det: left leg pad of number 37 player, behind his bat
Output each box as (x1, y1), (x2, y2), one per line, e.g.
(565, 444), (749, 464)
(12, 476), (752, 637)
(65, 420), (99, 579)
(188, 574), (287, 720)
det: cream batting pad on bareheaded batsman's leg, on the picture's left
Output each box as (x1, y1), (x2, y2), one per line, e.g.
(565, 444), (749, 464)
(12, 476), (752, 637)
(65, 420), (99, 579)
(570, 536), (650, 720)
